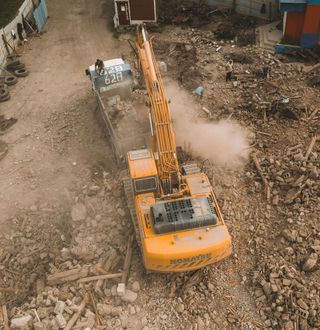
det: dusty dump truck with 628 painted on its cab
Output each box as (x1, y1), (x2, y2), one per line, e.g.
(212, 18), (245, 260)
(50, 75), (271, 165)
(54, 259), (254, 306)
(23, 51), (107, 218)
(87, 59), (150, 164)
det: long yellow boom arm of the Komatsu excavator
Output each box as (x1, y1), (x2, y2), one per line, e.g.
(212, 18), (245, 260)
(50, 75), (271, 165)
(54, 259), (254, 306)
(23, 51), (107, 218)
(137, 26), (179, 194)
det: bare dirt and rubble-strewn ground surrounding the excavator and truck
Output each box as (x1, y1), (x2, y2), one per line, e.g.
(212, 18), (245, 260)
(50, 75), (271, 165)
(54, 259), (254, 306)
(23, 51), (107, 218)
(0, 0), (320, 330)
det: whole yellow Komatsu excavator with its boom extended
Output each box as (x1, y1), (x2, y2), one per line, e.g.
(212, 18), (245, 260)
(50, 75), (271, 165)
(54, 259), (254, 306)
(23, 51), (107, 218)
(124, 25), (232, 272)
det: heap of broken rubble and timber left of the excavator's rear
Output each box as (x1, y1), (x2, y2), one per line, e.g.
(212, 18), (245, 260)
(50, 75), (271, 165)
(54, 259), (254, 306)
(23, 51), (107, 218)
(0, 172), (146, 329)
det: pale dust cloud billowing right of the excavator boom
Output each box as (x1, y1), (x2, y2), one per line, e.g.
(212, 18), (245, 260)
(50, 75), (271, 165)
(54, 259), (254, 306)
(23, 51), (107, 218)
(165, 81), (249, 168)
